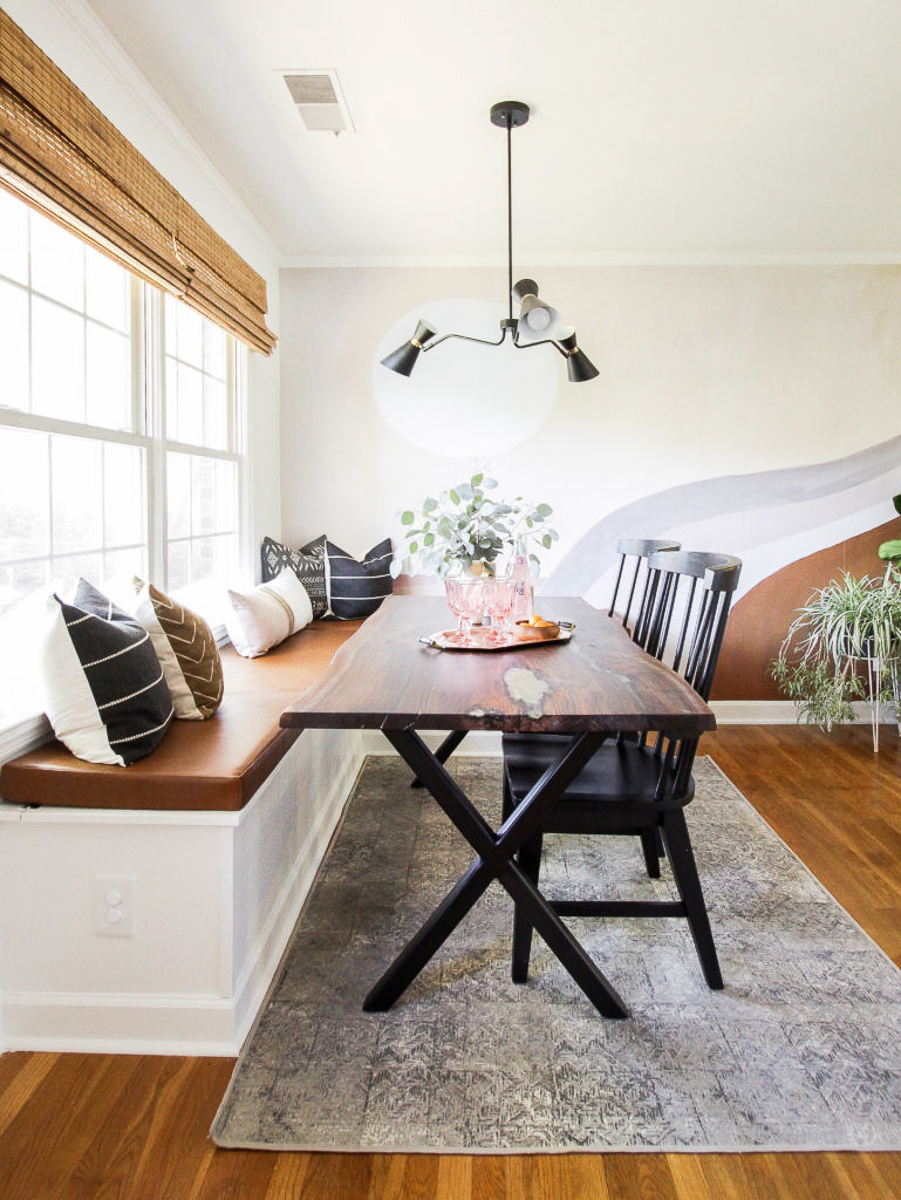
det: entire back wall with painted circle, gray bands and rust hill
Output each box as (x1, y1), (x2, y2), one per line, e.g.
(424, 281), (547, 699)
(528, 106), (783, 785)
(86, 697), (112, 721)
(278, 259), (901, 700)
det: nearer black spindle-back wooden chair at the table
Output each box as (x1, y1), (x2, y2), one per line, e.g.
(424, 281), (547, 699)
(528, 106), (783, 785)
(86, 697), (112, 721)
(504, 551), (741, 989)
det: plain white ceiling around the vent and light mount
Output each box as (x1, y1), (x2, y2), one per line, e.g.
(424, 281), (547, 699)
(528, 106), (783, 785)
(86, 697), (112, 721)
(89, 0), (901, 268)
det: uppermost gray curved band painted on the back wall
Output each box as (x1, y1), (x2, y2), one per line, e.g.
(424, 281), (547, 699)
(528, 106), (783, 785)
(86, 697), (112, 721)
(541, 436), (901, 595)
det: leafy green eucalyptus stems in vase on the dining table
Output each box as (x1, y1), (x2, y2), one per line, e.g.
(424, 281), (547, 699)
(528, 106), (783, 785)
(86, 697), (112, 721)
(391, 473), (558, 578)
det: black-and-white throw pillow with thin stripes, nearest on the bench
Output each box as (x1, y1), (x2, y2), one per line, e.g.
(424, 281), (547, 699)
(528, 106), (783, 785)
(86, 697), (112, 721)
(43, 580), (173, 767)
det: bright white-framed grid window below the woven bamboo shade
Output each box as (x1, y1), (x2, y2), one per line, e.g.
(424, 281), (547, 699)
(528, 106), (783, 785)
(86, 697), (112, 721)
(0, 191), (245, 721)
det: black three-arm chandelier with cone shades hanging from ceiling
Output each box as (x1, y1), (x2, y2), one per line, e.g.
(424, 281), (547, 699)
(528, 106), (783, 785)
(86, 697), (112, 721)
(382, 100), (597, 383)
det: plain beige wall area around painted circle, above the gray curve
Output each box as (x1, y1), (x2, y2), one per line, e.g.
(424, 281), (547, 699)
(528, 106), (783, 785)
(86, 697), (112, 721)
(282, 264), (901, 568)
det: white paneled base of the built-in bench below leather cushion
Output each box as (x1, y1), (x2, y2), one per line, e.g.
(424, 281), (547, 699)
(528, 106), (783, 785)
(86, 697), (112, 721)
(0, 731), (362, 1055)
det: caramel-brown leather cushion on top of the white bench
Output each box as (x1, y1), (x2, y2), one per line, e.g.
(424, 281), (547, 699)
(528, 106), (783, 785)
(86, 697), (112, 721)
(0, 620), (362, 811)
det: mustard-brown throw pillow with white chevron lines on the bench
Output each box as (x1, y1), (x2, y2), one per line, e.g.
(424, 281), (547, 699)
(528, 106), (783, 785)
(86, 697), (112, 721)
(133, 578), (222, 721)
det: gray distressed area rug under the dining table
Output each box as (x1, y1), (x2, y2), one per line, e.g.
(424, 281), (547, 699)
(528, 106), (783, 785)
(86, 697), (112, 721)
(212, 757), (901, 1153)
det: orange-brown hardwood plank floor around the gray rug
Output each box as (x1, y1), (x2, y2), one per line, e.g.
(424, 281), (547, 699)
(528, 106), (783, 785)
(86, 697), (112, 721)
(0, 726), (901, 1200)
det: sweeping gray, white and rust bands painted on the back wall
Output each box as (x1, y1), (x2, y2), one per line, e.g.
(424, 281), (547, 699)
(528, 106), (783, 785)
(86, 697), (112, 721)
(542, 437), (901, 700)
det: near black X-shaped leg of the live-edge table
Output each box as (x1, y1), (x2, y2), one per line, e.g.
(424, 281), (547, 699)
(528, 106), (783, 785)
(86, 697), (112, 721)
(364, 730), (629, 1016)
